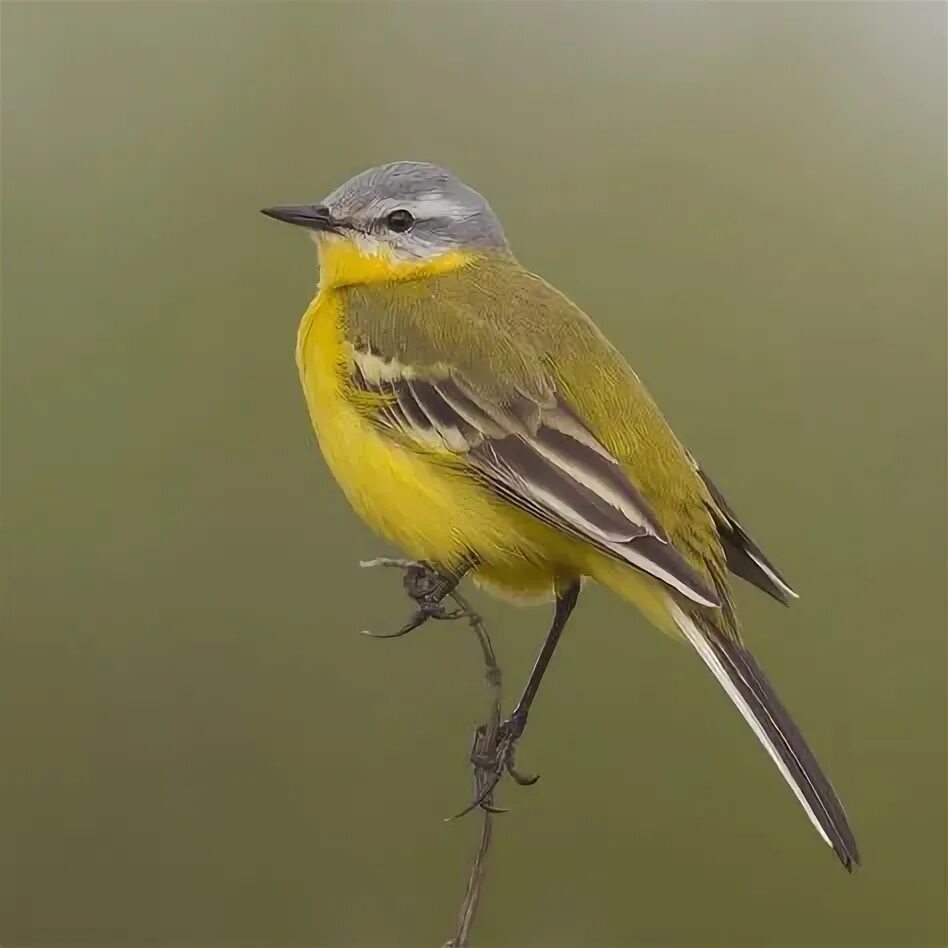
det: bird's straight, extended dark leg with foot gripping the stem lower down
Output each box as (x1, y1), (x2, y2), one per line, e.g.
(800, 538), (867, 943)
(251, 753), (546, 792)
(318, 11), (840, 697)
(458, 580), (580, 816)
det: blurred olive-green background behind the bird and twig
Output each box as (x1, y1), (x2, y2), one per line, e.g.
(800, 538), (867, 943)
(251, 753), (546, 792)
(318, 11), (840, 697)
(0, 2), (946, 948)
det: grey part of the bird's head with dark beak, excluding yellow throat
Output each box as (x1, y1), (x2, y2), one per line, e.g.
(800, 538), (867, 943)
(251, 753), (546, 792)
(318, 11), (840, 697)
(263, 161), (508, 261)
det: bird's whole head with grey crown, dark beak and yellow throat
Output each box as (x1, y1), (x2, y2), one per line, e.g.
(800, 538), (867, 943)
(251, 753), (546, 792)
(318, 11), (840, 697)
(263, 161), (509, 287)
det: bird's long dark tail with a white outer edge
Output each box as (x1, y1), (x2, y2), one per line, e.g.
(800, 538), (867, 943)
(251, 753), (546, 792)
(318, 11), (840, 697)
(669, 600), (859, 872)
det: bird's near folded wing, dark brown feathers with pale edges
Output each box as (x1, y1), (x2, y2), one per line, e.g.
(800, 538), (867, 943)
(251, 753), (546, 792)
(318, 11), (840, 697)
(351, 347), (720, 606)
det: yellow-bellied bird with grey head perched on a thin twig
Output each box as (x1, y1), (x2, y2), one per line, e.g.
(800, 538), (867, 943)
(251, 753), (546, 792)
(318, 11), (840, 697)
(262, 161), (860, 871)
